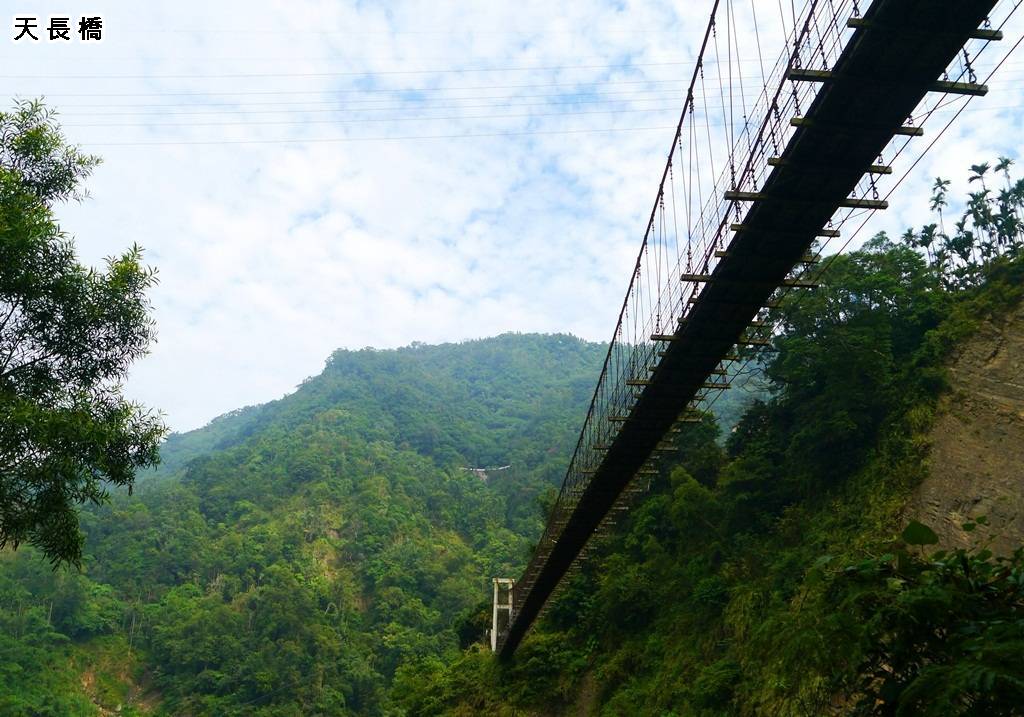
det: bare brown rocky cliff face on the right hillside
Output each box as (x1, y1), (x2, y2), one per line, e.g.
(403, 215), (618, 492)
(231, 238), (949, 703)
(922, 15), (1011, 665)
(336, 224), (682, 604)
(907, 306), (1024, 553)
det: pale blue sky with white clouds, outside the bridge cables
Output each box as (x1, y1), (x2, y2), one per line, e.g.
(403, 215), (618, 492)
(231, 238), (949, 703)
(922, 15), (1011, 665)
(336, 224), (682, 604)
(0, 0), (1024, 431)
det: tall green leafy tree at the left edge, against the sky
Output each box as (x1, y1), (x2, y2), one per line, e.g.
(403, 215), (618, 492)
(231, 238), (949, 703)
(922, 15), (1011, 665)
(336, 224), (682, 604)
(0, 101), (166, 565)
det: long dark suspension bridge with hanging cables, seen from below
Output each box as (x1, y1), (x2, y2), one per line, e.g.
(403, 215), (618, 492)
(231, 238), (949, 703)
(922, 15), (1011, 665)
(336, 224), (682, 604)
(492, 0), (1020, 658)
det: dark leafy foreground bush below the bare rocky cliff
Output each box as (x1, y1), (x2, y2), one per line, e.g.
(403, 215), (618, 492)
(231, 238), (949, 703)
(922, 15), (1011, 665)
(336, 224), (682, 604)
(817, 517), (1024, 716)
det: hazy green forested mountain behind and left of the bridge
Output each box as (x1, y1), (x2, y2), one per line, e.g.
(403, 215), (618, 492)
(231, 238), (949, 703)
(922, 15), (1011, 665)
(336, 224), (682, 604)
(0, 335), (605, 715)
